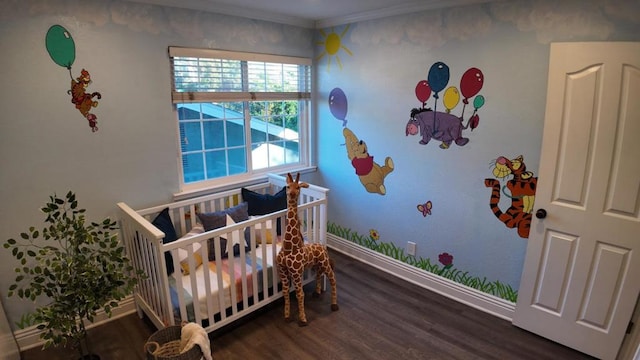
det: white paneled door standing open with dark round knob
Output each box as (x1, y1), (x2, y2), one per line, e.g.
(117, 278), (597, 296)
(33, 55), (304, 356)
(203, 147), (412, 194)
(513, 43), (640, 359)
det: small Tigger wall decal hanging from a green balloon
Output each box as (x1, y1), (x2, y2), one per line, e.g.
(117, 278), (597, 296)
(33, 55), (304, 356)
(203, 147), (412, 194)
(45, 25), (102, 132)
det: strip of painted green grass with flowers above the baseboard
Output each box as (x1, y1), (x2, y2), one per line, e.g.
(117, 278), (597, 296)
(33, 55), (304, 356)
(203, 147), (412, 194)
(327, 222), (518, 303)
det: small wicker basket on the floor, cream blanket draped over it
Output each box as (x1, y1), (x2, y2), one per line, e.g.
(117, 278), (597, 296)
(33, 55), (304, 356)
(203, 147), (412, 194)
(144, 325), (202, 360)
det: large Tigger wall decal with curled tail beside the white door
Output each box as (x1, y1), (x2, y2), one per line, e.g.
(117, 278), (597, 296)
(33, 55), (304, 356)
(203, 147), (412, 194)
(484, 155), (538, 239)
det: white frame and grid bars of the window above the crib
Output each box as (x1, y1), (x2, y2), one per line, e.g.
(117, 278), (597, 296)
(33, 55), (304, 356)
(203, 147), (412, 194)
(168, 46), (315, 198)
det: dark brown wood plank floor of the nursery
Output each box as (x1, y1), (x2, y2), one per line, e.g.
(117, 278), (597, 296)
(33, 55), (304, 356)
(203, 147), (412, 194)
(22, 252), (593, 360)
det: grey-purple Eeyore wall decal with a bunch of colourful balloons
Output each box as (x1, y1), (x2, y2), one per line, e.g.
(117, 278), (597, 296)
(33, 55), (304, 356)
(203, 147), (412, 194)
(405, 61), (485, 148)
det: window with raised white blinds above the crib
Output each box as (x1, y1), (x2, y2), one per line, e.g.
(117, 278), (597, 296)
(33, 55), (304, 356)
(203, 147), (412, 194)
(169, 47), (311, 188)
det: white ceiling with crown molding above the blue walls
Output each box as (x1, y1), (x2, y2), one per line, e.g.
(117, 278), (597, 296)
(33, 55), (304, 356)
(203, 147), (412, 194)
(129, 0), (491, 28)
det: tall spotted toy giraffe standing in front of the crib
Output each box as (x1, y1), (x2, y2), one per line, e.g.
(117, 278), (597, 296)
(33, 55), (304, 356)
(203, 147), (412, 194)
(276, 173), (338, 326)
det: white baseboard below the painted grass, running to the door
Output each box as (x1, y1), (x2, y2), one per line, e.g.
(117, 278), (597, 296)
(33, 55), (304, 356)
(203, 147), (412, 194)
(327, 234), (516, 321)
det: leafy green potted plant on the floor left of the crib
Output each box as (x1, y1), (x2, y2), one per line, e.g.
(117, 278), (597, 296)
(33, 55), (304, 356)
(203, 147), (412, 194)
(4, 191), (143, 359)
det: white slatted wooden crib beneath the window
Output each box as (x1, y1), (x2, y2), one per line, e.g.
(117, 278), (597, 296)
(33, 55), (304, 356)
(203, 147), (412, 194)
(118, 174), (329, 332)
